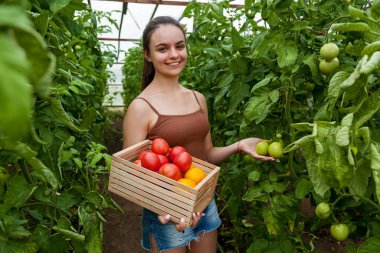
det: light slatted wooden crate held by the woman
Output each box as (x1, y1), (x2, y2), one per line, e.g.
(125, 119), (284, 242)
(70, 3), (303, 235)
(108, 140), (220, 225)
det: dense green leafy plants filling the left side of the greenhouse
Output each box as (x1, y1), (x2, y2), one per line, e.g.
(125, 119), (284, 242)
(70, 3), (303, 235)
(0, 0), (117, 253)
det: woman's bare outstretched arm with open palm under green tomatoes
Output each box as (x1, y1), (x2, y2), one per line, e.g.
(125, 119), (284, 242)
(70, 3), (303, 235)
(197, 92), (275, 164)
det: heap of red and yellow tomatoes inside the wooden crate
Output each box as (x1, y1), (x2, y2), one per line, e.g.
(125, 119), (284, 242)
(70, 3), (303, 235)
(133, 138), (206, 188)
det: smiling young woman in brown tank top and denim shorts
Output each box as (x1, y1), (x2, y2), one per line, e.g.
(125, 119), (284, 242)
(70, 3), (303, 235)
(123, 17), (274, 253)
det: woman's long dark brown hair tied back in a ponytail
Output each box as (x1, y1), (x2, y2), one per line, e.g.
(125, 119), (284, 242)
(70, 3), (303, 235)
(141, 16), (186, 90)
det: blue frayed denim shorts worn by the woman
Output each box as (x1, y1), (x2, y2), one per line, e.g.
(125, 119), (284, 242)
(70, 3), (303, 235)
(141, 199), (222, 252)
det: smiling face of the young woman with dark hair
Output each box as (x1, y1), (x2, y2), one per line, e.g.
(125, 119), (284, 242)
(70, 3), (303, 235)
(145, 24), (187, 77)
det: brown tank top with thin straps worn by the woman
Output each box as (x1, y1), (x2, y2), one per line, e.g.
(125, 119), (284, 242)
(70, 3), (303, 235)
(137, 92), (210, 160)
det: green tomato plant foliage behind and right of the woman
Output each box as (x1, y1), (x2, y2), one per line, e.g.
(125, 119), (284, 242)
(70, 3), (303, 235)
(124, 0), (380, 253)
